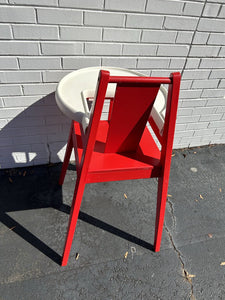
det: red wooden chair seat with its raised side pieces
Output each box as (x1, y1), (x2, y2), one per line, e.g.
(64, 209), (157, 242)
(74, 121), (161, 183)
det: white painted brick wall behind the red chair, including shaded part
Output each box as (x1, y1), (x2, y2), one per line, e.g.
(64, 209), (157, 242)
(0, 0), (225, 168)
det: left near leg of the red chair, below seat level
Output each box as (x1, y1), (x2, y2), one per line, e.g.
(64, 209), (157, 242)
(61, 178), (85, 266)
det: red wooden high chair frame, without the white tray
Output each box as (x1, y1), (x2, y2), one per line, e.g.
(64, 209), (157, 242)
(59, 70), (181, 266)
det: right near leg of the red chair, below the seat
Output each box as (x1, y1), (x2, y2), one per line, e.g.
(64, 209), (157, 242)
(154, 177), (168, 252)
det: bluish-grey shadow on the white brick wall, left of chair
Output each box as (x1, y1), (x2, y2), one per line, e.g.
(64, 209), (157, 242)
(0, 93), (70, 169)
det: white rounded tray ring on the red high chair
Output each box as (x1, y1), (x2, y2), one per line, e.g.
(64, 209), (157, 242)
(55, 66), (167, 130)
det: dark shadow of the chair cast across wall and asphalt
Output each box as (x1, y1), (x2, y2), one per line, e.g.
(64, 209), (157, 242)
(0, 93), (154, 264)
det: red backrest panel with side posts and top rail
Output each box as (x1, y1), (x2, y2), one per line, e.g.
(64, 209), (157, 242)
(84, 70), (180, 162)
